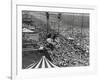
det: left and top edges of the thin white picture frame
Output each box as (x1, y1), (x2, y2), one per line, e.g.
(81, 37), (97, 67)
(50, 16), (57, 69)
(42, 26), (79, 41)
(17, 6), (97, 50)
(11, 3), (95, 80)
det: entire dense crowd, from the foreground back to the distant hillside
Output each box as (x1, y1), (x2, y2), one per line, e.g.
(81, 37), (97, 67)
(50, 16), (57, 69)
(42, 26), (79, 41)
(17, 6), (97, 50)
(23, 12), (89, 67)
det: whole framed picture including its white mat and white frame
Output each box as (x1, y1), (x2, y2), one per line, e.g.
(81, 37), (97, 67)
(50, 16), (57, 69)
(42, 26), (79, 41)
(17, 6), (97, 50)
(11, 2), (98, 80)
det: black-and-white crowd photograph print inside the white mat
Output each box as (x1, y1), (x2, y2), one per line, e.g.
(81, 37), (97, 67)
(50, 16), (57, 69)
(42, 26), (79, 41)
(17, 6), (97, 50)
(21, 10), (90, 69)
